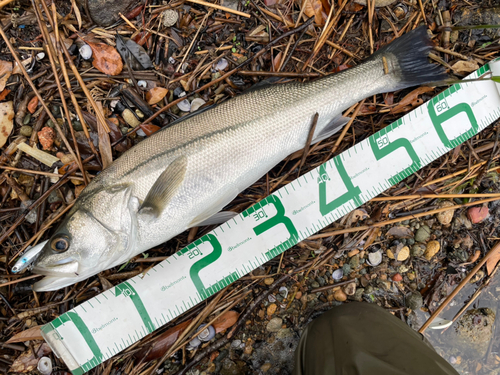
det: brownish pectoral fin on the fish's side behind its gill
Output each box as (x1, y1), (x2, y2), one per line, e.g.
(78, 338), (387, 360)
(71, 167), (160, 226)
(139, 156), (187, 217)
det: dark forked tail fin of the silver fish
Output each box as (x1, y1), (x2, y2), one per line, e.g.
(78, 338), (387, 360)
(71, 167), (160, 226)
(370, 26), (448, 90)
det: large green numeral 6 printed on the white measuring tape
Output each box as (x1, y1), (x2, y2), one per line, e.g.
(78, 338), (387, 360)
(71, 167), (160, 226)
(427, 91), (479, 148)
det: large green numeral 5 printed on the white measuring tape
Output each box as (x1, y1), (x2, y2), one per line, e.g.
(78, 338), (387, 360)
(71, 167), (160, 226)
(370, 120), (421, 185)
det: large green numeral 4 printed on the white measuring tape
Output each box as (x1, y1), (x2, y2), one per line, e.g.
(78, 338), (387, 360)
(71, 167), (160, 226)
(318, 156), (362, 216)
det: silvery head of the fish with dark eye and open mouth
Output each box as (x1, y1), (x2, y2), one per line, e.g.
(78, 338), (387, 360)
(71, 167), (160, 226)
(33, 209), (129, 291)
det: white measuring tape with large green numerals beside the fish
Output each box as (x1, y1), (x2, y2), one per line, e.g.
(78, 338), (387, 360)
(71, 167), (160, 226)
(42, 61), (500, 375)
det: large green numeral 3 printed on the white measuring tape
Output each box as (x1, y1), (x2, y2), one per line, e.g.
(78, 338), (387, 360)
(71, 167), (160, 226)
(243, 195), (298, 260)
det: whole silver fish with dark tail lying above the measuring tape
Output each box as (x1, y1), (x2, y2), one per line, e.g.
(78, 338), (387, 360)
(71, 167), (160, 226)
(29, 27), (447, 291)
